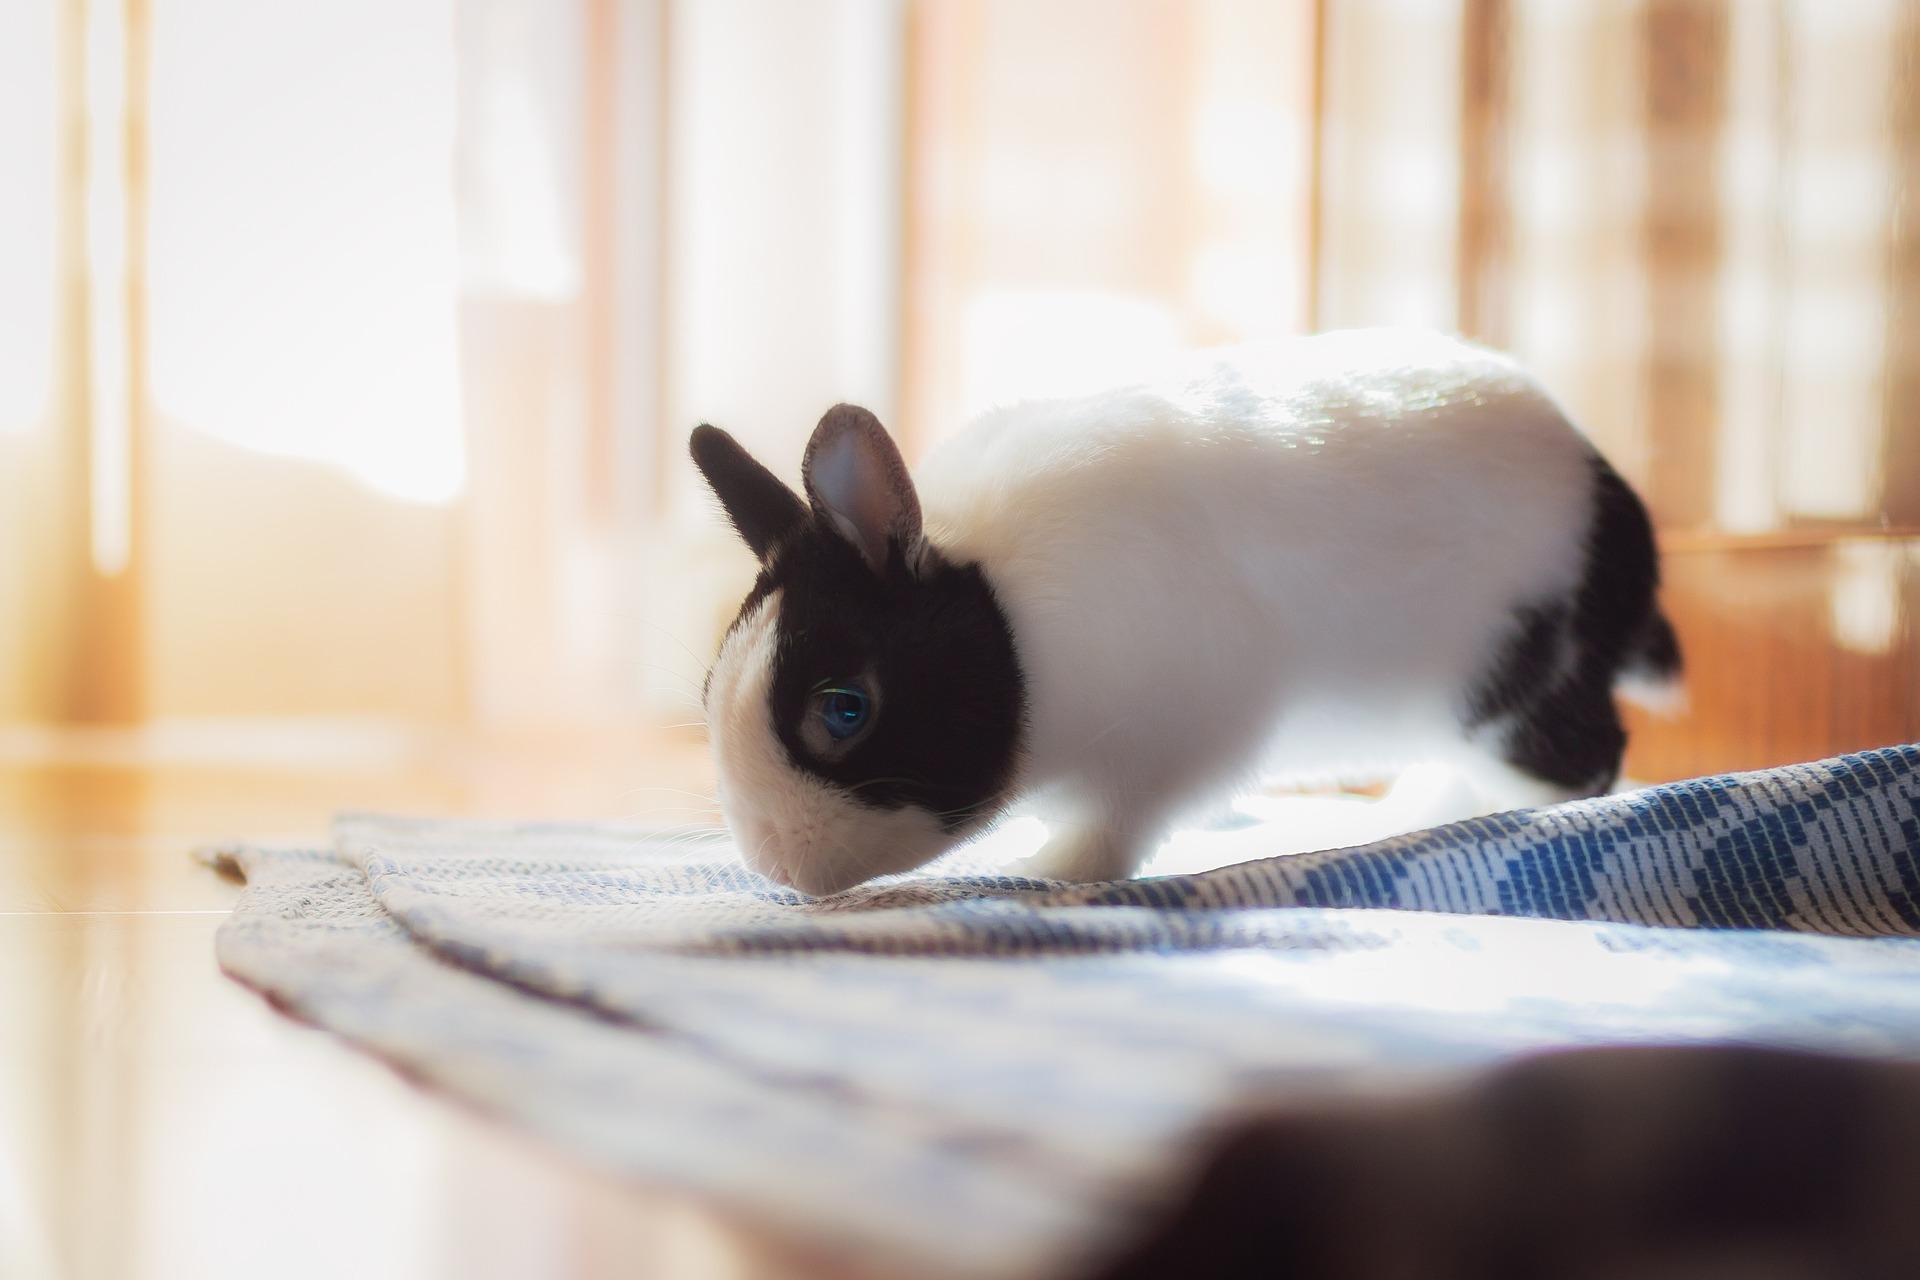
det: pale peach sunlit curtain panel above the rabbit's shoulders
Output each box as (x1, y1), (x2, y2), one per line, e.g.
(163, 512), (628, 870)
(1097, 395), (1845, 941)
(904, 0), (1315, 447)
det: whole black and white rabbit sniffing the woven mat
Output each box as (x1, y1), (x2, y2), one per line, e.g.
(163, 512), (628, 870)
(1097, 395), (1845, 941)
(689, 330), (1680, 896)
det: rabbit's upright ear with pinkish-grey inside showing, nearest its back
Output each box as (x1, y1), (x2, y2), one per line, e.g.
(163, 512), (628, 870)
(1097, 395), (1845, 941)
(801, 405), (922, 574)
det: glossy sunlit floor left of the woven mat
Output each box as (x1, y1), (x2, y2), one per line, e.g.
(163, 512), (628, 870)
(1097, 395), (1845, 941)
(0, 729), (898, 1280)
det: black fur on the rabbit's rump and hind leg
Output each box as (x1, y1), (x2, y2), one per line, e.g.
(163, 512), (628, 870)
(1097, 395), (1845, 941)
(1467, 453), (1680, 794)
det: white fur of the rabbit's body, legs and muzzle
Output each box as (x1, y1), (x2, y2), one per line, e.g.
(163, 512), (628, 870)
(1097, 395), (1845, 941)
(708, 330), (1628, 892)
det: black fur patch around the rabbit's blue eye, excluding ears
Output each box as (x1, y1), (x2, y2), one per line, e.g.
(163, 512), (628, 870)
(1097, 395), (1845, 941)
(747, 516), (1025, 833)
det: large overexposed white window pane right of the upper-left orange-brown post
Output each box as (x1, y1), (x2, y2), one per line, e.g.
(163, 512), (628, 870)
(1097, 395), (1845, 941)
(150, 0), (465, 503)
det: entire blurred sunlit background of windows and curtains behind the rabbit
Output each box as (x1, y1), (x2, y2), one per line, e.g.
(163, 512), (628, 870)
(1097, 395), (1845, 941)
(0, 0), (1920, 779)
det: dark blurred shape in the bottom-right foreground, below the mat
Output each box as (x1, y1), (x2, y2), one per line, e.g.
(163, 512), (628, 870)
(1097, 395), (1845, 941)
(1104, 1048), (1920, 1280)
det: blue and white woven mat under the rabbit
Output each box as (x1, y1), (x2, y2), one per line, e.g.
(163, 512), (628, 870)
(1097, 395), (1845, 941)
(219, 747), (1920, 1278)
